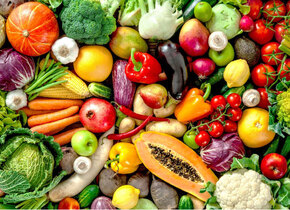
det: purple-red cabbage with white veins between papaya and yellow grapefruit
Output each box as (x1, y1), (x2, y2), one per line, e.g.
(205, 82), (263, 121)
(200, 133), (245, 172)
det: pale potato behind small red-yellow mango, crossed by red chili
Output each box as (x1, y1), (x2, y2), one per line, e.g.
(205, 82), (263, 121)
(133, 85), (153, 125)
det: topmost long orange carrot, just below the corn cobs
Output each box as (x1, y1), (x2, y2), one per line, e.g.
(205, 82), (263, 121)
(28, 98), (84, 110)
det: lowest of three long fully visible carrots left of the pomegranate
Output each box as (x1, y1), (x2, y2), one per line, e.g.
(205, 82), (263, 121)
(30, 114), (80, 134)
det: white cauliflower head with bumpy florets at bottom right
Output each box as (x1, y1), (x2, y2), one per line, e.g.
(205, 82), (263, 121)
(214, 169), (272, 209)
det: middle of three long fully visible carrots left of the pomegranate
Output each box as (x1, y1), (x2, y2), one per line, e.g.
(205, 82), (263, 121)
(28, 106), (79, 127)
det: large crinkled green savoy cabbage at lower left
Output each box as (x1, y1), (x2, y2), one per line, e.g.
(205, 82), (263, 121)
(0, 128), (66, 203)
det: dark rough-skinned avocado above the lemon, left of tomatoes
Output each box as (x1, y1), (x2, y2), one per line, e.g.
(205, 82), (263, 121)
(234, 36), (261, 67)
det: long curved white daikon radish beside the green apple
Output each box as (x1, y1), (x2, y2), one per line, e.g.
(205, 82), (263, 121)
(48, 126), (115, 202)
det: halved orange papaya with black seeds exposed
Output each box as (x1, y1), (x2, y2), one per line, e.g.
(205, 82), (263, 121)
(135, 131), (218, 201)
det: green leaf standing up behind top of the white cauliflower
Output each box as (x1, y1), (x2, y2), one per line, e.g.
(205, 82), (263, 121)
(231, 154), (260, 172)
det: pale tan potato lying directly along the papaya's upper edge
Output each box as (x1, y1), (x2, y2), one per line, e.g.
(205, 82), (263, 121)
(146, 119), (187, 137)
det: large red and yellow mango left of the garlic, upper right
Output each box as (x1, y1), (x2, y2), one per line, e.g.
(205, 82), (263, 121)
(179, 18), (209, 56)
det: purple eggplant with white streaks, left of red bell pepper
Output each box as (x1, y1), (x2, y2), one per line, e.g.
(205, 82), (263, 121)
(113, 60), (136, 108)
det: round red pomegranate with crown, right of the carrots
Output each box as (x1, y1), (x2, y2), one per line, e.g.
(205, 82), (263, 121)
(80, 98), (116, 133)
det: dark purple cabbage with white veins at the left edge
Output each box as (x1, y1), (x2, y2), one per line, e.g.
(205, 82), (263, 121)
(0, 48), (35, 91)
